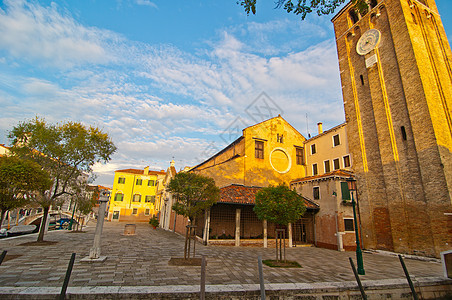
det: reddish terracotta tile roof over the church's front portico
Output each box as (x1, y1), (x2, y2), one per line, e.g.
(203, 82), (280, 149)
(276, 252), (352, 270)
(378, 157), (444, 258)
(218, 184), (319, 210)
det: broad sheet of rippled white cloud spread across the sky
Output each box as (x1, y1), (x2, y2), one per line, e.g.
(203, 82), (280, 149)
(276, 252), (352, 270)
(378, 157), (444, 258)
(0, 0), (343, 184)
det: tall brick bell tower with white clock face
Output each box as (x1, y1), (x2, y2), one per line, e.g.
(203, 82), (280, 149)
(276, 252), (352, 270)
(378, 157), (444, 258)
(332, 0), (452, 257)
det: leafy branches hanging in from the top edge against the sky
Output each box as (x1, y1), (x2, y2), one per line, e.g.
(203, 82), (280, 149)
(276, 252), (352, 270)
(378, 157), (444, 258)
(237, 0), (369, 20)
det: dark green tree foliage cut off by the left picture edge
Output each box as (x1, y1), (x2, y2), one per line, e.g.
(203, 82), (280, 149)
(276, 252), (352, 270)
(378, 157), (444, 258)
(0, 156), (52, 228)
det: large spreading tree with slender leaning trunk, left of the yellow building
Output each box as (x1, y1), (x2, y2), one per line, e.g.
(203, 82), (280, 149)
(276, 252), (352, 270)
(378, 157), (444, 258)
(8, 117), (116, 242)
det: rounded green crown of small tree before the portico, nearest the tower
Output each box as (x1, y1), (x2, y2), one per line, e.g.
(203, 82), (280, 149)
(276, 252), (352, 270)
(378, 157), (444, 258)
(254, 185), (306, 225)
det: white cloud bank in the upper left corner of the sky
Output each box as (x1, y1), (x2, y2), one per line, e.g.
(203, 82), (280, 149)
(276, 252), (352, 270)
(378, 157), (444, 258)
(0, 0), (115, 67)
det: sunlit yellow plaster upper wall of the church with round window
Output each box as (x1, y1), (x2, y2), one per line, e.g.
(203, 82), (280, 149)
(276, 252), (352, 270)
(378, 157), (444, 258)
(194, 116), (306, 187)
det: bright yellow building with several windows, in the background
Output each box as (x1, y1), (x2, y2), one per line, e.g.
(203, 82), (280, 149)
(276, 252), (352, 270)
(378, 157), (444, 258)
(108, 167), (165, 222)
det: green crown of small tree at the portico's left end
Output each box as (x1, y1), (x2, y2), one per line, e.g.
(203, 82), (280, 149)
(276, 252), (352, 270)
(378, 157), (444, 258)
(168, 172), (220, 222)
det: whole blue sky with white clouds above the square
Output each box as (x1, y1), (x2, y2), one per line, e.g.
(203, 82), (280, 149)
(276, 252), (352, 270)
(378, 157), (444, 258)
(0, 0), (452, 186)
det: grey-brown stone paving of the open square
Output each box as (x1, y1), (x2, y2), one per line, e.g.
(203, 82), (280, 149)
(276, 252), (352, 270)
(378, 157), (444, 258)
(0, 222), (443, 287)
